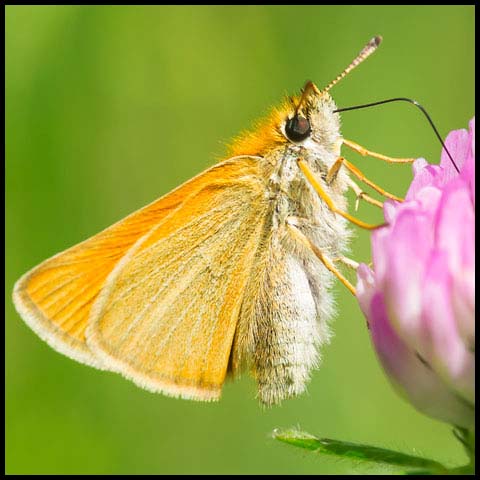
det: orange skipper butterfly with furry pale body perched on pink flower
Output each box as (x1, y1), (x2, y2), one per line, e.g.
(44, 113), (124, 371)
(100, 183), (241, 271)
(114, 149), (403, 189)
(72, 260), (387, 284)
(14, 37), (406, 405)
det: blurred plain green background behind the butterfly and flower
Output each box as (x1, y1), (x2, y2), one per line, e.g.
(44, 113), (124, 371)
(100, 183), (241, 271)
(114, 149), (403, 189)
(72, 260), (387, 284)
(6, 6), (474, 474)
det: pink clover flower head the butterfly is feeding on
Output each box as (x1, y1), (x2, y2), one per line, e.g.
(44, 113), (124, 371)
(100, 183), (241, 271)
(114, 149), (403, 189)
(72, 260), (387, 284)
(357, 119), (475, 428)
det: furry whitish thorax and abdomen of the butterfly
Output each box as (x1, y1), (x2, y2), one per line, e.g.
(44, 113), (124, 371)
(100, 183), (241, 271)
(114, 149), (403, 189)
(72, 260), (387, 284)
(231, 98), (348, 405)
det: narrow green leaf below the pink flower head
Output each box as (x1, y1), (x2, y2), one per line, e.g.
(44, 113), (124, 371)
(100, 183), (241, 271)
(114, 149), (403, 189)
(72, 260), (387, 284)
(273, 430), (448, 475)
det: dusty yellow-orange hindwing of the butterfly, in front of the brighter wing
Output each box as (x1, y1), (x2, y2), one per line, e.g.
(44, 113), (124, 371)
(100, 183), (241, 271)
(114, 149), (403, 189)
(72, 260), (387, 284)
(87, 160), (267, 400)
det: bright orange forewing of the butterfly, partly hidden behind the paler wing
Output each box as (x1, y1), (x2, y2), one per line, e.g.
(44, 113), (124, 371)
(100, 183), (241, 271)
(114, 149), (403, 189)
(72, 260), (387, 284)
(13, 157), (266, 378)
